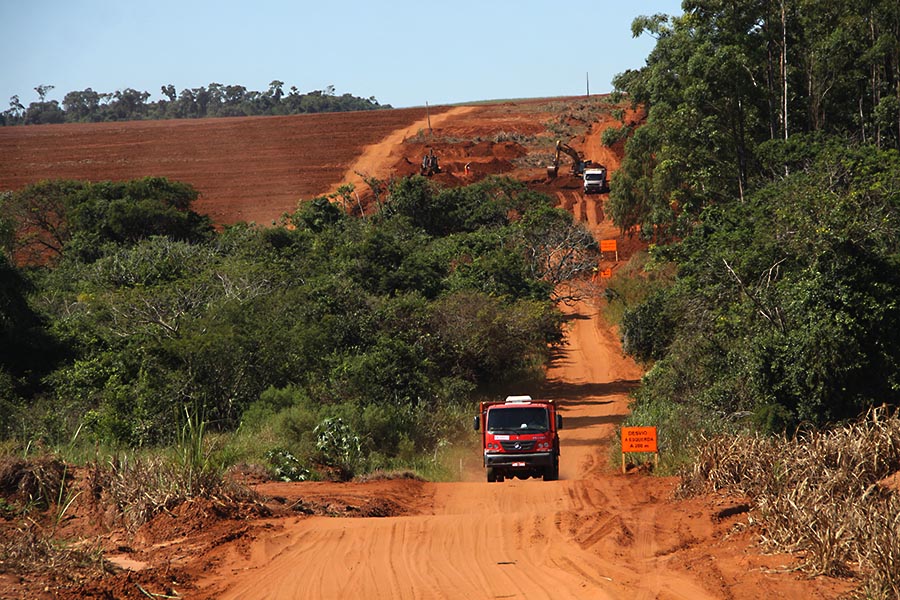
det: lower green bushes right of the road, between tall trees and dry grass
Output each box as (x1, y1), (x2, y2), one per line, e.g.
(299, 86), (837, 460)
(623, 143), (900, 431)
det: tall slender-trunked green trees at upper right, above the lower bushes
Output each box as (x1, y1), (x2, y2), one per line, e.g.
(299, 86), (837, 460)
(610, 0), (900, 239)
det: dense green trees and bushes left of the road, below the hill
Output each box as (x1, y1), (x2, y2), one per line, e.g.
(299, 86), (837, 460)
(0, 176), (597, 476)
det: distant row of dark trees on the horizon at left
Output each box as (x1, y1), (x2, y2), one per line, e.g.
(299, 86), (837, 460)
(0, 80), (391, 125)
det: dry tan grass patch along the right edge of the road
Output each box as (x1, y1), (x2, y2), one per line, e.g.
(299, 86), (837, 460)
(680, 408), (900, 598)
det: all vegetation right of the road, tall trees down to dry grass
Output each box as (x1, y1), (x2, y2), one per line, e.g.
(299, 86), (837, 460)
(604, 0), (900, 598)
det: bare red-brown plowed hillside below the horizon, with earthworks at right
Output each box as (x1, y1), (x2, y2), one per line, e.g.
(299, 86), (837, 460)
(0, 99), (619, 241)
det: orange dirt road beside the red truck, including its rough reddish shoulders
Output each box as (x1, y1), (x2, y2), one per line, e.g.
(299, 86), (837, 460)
(191, 306), (846, 600)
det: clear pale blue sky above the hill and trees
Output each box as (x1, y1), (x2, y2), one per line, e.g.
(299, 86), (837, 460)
(0, 0), (681, 111)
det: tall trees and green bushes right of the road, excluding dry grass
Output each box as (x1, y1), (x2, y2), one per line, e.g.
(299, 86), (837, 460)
(607, 0), (900, 432)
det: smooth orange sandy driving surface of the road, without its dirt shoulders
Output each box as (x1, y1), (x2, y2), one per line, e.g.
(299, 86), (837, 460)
(197, 306), (718, 599)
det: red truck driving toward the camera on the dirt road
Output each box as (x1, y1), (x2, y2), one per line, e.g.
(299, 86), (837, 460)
(474, 396), (562, 482)
